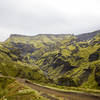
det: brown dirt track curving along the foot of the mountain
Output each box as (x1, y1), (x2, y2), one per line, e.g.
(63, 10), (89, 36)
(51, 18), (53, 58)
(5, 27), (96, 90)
(17, 79), (100, 100)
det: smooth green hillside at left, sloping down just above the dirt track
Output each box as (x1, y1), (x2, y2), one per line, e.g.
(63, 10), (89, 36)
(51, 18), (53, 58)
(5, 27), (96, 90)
(0, 44), (45, 81)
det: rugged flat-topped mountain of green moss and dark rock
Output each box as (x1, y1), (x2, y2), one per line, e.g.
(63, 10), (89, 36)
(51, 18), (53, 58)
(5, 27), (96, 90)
(0, 31), (100, 89)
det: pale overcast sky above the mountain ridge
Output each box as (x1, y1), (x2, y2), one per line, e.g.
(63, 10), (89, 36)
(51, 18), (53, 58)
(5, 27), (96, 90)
(0, 0), (100, 41)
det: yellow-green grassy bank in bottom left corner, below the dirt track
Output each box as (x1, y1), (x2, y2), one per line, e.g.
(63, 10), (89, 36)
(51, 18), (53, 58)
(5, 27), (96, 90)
(0, 77), (47, 100)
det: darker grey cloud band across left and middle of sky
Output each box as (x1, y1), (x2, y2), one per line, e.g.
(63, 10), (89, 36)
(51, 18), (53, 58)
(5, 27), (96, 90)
(0, 2), (66, 32)
